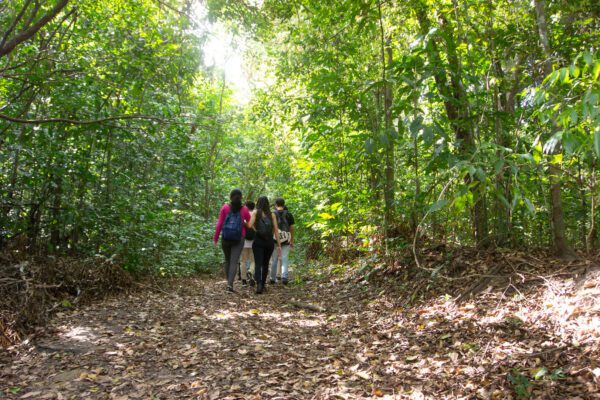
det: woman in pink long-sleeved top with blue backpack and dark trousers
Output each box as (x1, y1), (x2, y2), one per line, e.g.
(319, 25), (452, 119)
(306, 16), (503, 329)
(213, 189), (250, 293)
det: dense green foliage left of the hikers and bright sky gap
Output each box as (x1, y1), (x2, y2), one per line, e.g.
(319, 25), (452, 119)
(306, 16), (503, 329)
(0, 0), (242, 274)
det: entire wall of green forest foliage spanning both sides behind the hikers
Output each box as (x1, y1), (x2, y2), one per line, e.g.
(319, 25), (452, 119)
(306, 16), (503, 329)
(0, 0), (600, 274)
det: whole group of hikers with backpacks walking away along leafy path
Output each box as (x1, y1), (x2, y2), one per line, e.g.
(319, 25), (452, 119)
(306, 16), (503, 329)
(213, 189), (294, 294)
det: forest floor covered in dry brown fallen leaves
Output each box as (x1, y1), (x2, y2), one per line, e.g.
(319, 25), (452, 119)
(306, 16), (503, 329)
(0, 252), (600, 399)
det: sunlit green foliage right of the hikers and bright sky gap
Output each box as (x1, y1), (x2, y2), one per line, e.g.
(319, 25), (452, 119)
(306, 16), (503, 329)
(251, 0), (600, 252)
